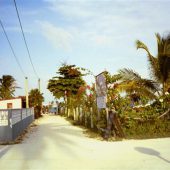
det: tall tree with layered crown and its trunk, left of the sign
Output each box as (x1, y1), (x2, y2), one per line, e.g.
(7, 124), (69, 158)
(47, 64), (88, 117)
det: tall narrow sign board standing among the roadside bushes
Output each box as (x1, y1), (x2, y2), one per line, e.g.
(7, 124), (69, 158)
(96, 73), (107, 109)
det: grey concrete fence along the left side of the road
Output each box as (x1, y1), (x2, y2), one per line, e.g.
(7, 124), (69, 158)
(0, 108), (34, 142)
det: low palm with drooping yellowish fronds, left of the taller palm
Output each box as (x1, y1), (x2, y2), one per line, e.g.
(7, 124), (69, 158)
(118, 68), (159, 99)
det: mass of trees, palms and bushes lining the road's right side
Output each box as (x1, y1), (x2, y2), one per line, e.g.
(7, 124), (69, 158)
(48, 34), (170, 138)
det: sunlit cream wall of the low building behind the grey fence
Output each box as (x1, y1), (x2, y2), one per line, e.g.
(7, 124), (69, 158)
(0, 98), (22, 109)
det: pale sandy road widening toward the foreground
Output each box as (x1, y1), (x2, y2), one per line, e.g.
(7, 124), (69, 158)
(0, 116), (170, 170)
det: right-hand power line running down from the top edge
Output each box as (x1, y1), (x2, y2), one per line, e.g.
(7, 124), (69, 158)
(14, 0), (38, 78)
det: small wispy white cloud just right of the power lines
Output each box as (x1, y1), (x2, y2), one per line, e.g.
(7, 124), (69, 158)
(38, 21), (73, 50)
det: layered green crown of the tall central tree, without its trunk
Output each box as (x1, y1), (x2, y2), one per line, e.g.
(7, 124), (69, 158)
(47, 64), (86, 98)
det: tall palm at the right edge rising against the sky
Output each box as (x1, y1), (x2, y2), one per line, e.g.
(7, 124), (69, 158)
(136, 33), (170, 97)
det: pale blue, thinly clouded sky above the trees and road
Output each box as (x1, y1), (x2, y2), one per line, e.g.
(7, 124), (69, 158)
(0, 0), (170, 104)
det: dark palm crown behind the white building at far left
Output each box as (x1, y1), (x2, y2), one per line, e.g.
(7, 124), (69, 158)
(0, 75), (17, 99)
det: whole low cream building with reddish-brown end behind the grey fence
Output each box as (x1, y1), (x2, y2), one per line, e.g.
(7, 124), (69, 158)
(0, 96), (26, 109)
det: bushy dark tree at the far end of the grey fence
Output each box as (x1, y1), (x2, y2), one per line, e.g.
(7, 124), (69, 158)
(29, 89), (44, 119)
